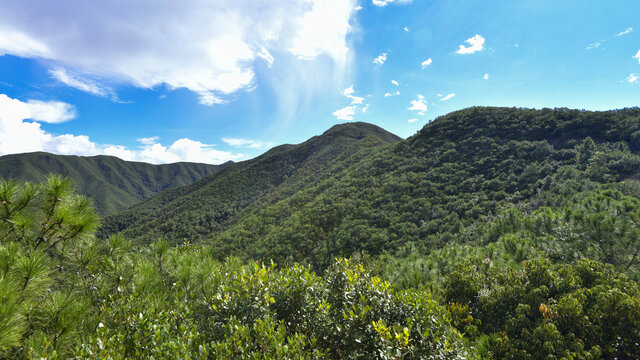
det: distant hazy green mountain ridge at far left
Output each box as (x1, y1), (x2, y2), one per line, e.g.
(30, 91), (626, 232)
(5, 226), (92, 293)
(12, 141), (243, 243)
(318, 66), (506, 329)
(0, 152), (230, 215)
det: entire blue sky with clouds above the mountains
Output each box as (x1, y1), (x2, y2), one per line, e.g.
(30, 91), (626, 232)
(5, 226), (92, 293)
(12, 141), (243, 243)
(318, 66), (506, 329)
(0, 0), (640, 164)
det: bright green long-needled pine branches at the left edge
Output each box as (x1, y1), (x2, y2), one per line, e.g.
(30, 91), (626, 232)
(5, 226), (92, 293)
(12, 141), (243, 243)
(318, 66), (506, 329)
(0, 176), (98, 356)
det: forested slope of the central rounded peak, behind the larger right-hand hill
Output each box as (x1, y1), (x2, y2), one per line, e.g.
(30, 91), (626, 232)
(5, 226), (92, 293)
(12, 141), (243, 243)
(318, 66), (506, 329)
(101, 123), (401, 242)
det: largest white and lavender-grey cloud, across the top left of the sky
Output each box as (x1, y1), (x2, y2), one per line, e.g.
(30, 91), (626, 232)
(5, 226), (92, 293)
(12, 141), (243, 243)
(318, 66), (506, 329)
(0, 0), (357, 105)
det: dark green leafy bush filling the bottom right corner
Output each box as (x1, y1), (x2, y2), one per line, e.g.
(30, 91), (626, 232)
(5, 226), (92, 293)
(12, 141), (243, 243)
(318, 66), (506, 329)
(444, 260), (640, 359)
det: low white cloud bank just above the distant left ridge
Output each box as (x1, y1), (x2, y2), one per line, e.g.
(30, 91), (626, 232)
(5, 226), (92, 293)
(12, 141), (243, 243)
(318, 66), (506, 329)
(0, 94), (244, 164)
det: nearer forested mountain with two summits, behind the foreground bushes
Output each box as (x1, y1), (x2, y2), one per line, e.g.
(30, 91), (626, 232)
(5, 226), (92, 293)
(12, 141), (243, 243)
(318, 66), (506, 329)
(102, 107), (640, 268)
